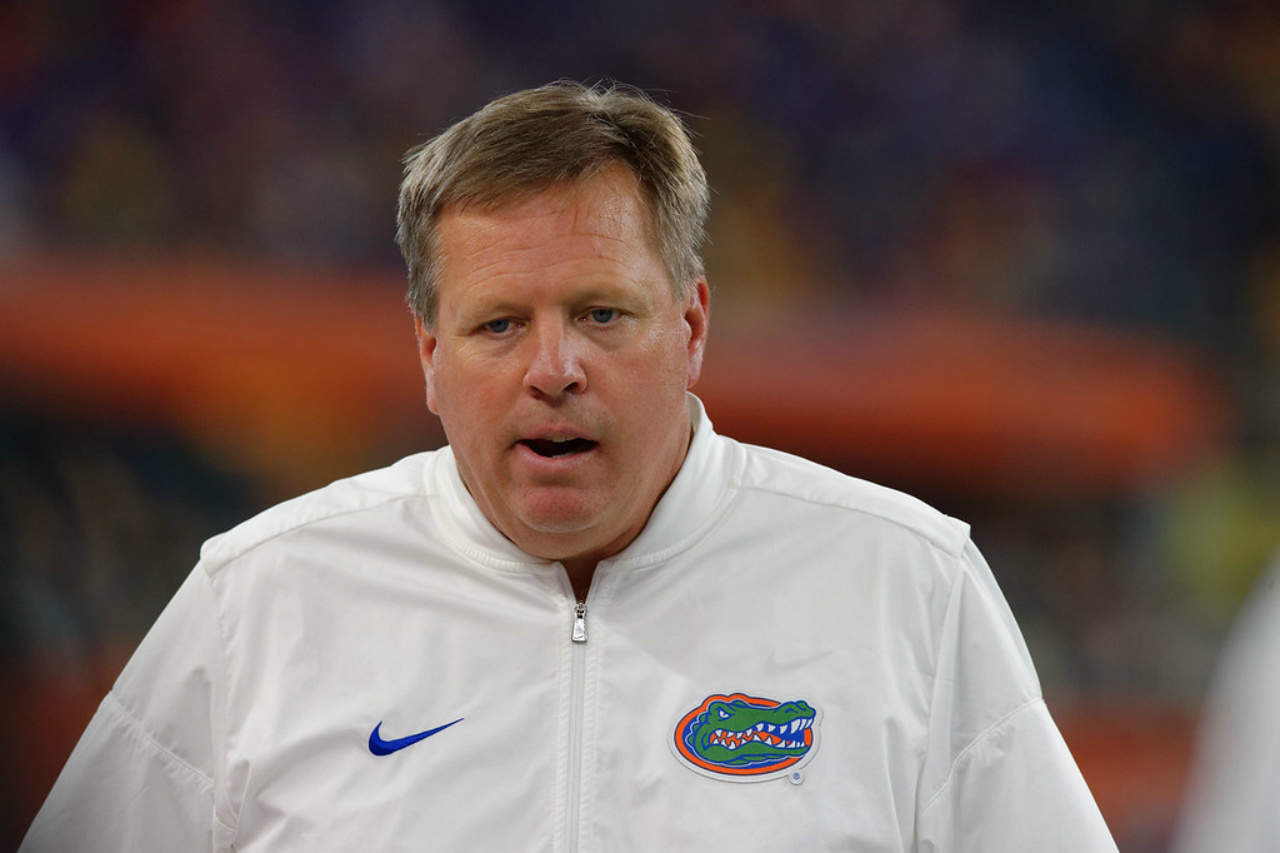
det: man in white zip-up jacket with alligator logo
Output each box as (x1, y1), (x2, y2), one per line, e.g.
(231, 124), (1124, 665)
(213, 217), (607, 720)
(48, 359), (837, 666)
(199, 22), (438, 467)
(27, 85), (1115, 853)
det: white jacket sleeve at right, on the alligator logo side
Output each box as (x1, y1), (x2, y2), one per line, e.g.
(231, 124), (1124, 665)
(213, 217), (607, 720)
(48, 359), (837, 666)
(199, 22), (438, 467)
(916, 542), (1116, 853)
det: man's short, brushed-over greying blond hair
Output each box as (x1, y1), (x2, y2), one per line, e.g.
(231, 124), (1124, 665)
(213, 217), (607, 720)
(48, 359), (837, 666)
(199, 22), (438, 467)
(396, 81), (709, 325)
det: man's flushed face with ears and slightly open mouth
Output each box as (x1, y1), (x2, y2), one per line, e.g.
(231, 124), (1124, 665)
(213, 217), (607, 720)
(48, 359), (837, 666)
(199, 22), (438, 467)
(419, 167), (708, 567)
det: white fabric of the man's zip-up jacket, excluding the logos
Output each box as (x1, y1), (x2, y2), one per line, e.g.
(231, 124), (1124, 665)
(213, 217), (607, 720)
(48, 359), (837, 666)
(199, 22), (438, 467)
(23, 398), (1115, 853)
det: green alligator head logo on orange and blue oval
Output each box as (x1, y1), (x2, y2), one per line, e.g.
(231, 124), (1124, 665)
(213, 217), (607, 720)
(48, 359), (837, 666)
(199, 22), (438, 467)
(672, 693), (818, 781)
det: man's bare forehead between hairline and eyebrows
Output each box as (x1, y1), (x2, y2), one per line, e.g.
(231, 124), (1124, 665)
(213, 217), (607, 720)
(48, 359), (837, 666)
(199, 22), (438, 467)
(436, 165), (668, 304)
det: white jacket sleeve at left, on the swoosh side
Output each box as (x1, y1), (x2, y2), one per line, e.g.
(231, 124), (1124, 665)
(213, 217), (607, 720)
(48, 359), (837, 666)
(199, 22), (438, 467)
(19, 566), (234, 853)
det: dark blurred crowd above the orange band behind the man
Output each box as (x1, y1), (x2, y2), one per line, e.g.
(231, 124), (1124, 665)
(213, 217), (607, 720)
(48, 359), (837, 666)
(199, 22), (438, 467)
(0, 0), (1280, 333)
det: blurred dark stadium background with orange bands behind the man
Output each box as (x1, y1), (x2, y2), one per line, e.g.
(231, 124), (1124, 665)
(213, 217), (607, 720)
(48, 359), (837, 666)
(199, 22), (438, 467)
(0, 0), (1280, 850)
